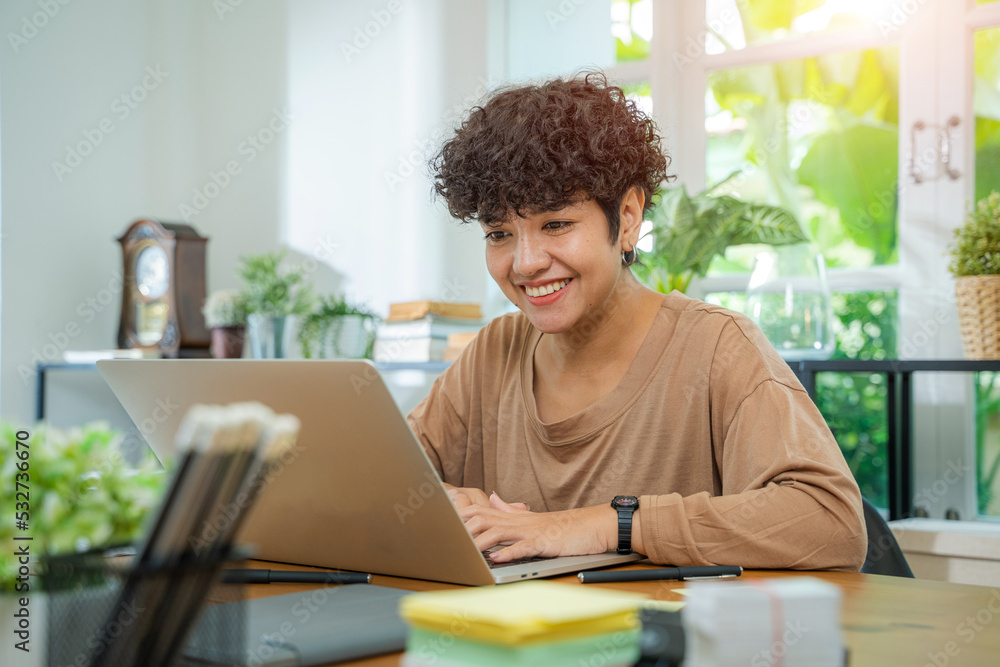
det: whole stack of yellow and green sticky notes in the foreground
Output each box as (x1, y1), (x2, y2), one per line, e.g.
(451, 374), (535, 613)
(400, 581), (645, 667)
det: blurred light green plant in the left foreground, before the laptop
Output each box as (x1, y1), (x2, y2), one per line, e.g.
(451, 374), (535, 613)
(0, 423), (167, 665)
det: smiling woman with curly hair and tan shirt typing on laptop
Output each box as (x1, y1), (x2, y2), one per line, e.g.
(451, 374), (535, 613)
(409, 73), (866, 571)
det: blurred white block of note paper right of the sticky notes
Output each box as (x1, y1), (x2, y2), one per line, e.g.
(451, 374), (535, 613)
(682, 577), (846, 667)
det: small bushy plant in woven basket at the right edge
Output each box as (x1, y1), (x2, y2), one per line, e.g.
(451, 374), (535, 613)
(948, 191), (1000, 359)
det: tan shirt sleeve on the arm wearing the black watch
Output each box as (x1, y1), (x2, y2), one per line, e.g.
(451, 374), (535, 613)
(639, 320), (867, 572)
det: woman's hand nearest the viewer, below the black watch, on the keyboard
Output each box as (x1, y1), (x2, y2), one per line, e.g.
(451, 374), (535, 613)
(459, 496), (618, 563)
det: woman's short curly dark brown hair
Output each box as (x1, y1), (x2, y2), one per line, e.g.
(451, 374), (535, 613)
(430, 72), (670, 243)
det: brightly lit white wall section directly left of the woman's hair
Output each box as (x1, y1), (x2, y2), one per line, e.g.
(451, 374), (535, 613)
(286, 0), (488, 311)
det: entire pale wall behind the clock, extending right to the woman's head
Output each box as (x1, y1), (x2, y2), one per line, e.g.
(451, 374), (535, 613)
(0, 0), (487, 423)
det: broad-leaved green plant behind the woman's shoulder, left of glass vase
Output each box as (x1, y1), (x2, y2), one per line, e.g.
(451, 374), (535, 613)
(633, 172), (808, 292)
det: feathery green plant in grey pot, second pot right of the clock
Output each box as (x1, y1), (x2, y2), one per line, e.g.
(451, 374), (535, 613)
(238, 251), (312, 359)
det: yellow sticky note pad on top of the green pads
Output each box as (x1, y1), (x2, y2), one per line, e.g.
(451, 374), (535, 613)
(400, 581), (647, 645)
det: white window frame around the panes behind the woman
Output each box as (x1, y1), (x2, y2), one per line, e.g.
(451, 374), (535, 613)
(596, 0), (1000, 517)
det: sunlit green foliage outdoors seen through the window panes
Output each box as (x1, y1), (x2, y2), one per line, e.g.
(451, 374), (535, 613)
(706, 0), (1000, 515)
